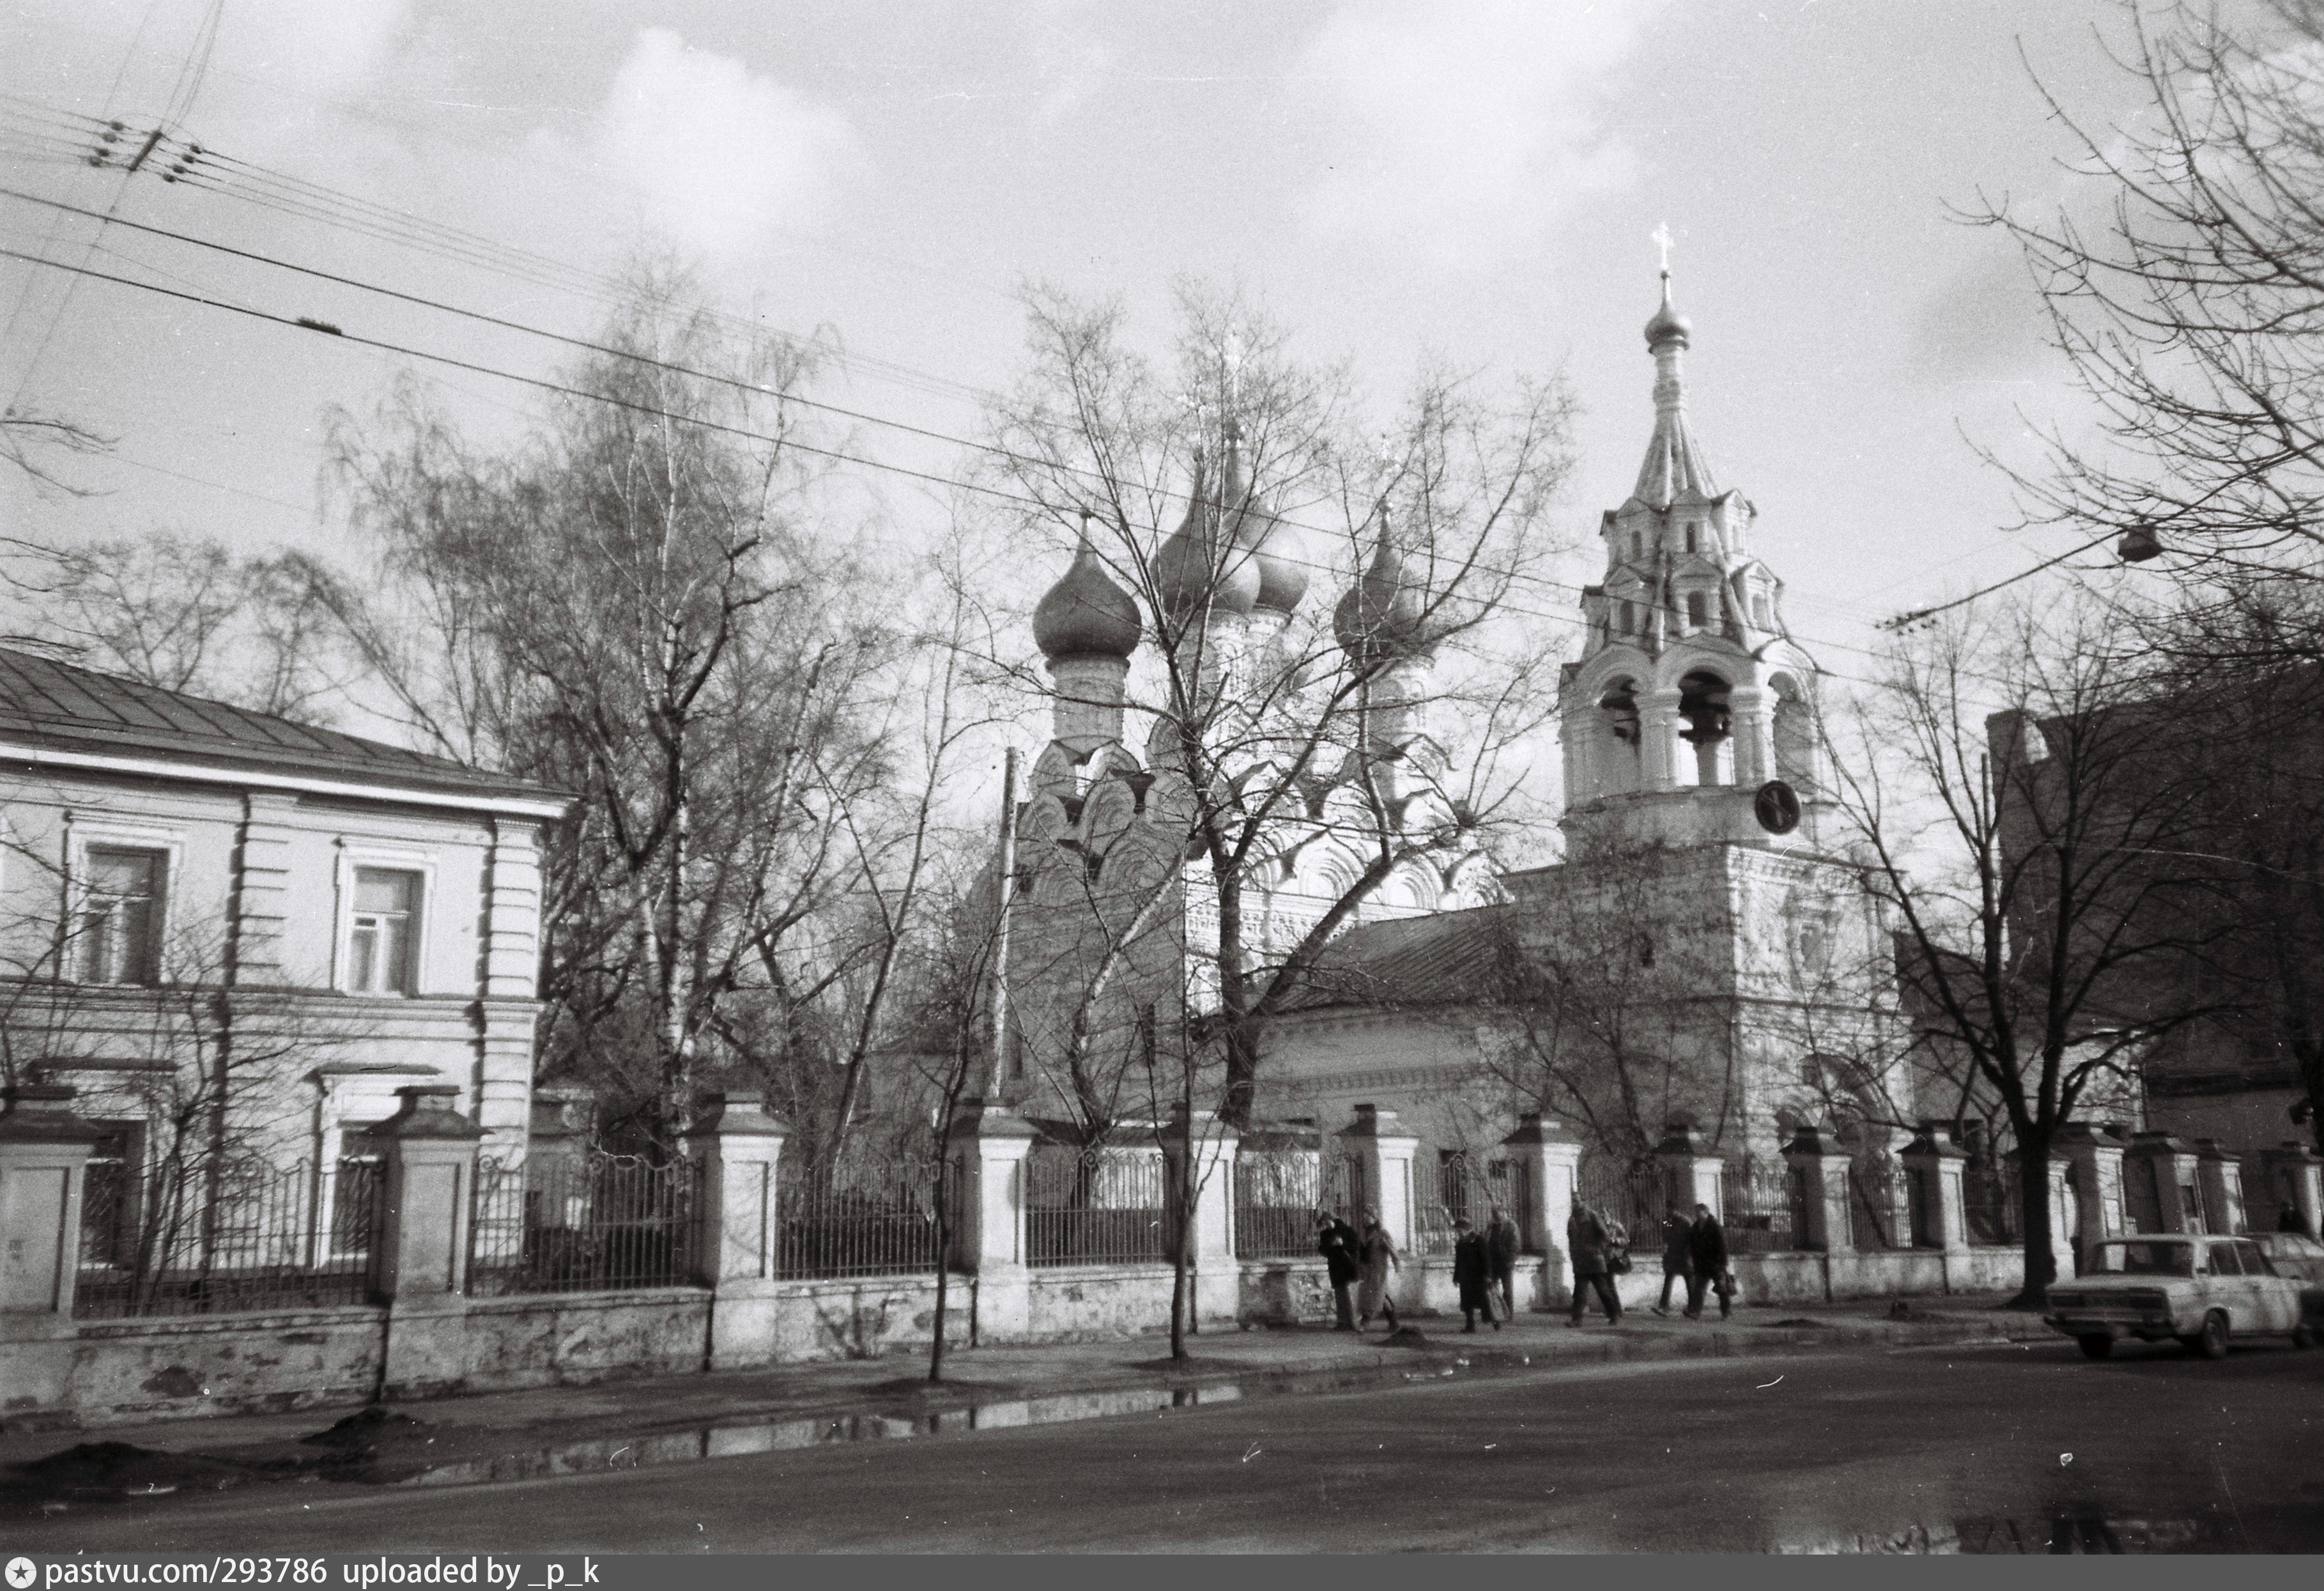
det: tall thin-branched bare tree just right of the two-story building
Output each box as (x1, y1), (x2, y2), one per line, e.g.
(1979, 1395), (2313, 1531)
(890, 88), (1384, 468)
(335, 274), (932, 1152)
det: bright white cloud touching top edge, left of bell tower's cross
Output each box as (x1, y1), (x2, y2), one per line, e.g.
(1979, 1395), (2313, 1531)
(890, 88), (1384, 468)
(1297, 0), (1661, 265)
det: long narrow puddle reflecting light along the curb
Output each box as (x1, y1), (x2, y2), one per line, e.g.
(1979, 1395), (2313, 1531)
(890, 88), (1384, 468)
(390, 1378), (1264, 1486)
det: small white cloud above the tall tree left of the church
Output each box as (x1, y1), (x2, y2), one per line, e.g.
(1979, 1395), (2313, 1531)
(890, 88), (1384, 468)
(567, 28), (860, 265)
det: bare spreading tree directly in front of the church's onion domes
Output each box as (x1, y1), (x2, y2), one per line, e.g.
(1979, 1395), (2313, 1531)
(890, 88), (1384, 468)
(992, 286), (1569, 1124)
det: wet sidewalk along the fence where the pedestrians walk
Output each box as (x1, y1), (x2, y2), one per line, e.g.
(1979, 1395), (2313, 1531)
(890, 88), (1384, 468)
(0, 1294), (2052, 1512)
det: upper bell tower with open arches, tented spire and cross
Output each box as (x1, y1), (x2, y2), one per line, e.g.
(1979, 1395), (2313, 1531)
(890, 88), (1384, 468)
(1559, 265), (1822, 848)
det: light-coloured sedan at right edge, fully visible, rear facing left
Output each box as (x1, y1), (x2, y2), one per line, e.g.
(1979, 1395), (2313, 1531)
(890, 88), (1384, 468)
(2043, 1233), (2314, 1358)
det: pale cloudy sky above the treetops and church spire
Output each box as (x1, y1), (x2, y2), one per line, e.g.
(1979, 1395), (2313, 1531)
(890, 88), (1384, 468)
(0, 0), (2212, 687)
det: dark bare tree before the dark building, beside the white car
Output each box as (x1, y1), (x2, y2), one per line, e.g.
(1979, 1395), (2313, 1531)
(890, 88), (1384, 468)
(1831, 601), (2212, 1308)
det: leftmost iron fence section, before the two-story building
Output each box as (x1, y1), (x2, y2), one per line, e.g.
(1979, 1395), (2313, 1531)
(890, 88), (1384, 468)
(72, 1159), (379, 1319)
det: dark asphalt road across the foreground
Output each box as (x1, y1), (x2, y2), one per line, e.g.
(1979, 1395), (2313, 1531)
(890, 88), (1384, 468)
(10, 1340), (2324, 1551)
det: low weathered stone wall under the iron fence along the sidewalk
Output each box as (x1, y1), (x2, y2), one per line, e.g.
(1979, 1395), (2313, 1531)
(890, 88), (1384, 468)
(0, 1247), (2024, 1424)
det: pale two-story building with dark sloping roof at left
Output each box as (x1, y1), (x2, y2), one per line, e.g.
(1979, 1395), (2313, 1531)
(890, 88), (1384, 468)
(0, 650), (572, 1287)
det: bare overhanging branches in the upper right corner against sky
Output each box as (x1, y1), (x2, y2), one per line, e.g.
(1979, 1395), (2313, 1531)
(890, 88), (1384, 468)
(1969, 0), (2324, 585)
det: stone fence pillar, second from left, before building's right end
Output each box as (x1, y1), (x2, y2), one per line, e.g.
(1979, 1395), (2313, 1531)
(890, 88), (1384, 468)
(362, 1082), (483, 1398)
